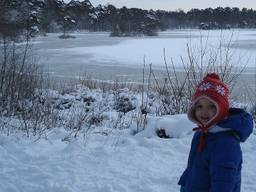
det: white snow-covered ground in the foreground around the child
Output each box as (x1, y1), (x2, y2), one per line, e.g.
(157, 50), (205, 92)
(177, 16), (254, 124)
(0, 86), (256, 192)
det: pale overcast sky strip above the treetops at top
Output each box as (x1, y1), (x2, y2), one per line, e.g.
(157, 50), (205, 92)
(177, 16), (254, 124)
(65, 0), (256, 11)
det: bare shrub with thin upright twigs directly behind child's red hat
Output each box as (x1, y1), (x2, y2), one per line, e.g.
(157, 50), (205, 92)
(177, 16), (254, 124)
(184, 32), (248, 95)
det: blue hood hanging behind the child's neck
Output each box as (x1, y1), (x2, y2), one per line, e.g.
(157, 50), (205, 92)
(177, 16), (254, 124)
(217, 108), (253, 142)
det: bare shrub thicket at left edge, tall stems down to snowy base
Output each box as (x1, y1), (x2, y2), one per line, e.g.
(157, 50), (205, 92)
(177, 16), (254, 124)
(0, 37), (63, 137)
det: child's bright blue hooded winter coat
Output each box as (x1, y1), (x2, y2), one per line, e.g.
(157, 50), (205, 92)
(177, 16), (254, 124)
(178, 108), (253, 192)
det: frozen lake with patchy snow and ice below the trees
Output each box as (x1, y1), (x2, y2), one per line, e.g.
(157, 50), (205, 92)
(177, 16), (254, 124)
(33, 30), (256, 97)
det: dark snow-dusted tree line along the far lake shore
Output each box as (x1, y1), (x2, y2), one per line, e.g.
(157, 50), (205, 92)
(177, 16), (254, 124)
(0, 0), (256, 37)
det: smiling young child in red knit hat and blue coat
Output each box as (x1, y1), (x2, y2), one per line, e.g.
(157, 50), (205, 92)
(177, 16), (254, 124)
(178, 73), (253, 192)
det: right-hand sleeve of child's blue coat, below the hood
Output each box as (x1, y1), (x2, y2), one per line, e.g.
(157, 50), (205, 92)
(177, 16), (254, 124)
(210, 136), (242, 192)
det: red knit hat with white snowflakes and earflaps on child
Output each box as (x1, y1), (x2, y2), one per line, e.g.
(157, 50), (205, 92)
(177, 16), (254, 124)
(188, 73), (229, 129)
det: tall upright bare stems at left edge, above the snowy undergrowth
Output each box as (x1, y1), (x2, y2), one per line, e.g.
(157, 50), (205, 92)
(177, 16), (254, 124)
(0, 39), (42, 115)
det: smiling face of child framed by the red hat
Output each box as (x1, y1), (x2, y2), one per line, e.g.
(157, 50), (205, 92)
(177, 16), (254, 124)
(195, 98), (217, 124)
